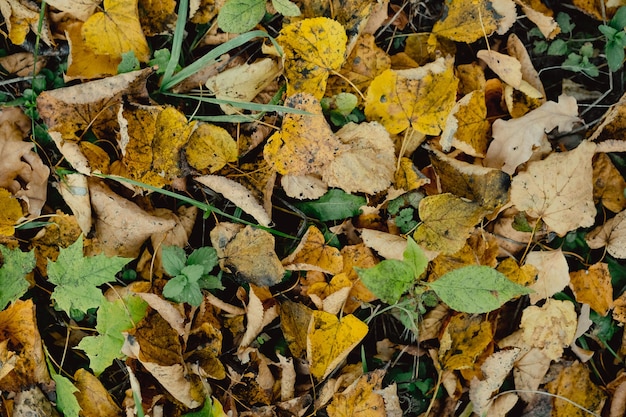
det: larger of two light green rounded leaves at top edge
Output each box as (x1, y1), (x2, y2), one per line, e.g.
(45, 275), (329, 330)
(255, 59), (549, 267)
(217, 0), (265, 33)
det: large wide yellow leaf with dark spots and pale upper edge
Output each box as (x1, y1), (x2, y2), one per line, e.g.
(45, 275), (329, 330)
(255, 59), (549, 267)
(365, 58), (458, 135)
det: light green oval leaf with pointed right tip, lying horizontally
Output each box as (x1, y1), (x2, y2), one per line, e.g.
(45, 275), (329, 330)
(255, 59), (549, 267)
(428, 265), (532, 313)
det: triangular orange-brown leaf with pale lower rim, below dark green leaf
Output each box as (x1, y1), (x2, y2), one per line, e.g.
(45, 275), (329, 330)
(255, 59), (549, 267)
(282, 226), (343, 275)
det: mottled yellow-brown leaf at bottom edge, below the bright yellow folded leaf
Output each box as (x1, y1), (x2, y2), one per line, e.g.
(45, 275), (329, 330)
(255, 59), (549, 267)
(326, 369), (387, 417)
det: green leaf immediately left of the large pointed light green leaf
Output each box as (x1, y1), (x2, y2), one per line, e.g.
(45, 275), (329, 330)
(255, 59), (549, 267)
(354, 259), (415, 304)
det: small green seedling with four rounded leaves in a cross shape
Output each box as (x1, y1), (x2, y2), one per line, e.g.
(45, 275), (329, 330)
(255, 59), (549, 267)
(162, 246), (224, 306)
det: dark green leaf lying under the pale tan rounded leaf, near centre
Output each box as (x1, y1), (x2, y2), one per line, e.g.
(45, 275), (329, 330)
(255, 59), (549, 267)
(296, 188), (367, 222)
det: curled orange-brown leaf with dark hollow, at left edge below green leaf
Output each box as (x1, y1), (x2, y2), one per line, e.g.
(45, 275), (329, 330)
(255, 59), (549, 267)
(0, 299), (51, 392)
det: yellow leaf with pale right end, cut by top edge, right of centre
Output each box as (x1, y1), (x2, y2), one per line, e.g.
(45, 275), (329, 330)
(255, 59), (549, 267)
(433, 0), (517, 43)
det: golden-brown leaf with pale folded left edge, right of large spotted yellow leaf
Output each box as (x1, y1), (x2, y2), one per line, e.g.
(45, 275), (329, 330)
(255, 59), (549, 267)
(439, 90), (490, 158)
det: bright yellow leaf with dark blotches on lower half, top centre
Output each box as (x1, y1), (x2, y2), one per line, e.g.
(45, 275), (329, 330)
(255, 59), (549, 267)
(277, 17), (348, 100)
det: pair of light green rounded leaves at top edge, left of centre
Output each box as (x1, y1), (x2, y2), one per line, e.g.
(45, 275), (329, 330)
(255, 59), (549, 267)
(217, 0), (300, 33)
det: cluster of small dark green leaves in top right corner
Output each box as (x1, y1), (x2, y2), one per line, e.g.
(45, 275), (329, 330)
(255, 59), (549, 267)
(530, 6), (626, 77)
